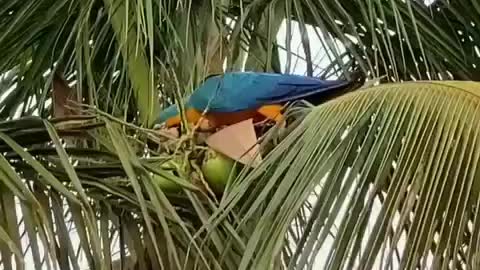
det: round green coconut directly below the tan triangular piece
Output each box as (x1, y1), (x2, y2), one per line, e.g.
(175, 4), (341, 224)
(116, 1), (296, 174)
(202, 149), (237, 193)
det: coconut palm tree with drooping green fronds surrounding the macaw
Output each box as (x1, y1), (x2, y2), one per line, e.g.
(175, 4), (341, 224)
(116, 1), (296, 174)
(0, 0), (480, 269)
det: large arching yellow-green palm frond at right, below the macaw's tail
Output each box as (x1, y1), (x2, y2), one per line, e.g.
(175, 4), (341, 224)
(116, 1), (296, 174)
(207, 82), (480, 269)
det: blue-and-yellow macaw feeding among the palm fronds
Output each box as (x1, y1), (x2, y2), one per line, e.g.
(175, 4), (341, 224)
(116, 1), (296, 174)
(155, 72), (362, 128)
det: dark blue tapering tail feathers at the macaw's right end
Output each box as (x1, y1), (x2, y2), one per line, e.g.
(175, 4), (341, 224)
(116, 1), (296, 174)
(264, 71), (366, 105)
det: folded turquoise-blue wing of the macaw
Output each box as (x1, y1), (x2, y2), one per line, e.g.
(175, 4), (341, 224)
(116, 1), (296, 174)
(189, 72), (350, 112)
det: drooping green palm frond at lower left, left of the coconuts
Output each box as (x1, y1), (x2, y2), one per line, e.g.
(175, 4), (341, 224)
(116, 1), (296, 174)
(0, 116), (235, 269)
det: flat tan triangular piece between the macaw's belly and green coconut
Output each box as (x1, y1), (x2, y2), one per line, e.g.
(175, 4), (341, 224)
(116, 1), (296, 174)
(206, 118), (262, 167)
